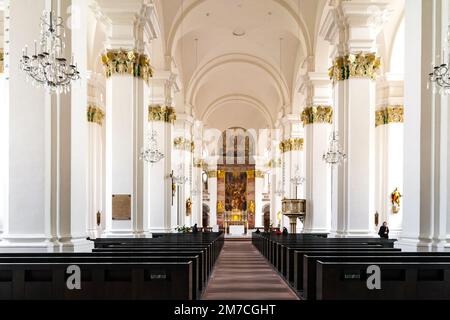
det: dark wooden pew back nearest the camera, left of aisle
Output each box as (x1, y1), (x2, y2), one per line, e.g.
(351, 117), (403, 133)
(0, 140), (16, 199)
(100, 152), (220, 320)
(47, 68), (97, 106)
(0, 262), (193, 300)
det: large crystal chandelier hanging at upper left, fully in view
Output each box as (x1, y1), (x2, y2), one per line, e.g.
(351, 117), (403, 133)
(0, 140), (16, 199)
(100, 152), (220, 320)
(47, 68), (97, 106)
(20, 11), (80, 94)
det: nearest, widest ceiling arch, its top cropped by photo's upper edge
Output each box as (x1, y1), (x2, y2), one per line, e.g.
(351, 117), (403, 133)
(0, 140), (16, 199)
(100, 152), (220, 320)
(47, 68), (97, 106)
(166, 0), (312, 56)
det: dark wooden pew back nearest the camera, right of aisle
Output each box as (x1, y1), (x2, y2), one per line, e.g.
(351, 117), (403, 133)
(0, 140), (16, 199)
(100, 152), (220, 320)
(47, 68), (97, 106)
(316, 261), (450, 300)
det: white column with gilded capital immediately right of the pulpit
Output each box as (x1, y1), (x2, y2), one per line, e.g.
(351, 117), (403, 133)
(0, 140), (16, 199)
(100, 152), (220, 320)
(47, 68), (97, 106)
(302, 72), (333, 233)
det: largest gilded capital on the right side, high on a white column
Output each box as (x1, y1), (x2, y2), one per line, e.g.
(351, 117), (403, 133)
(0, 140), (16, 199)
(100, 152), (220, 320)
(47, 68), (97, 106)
(328, 52), (381, 81)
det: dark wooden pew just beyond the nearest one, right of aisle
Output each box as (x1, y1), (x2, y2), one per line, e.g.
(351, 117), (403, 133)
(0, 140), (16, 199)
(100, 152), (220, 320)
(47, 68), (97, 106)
(302, 252), (450, 300)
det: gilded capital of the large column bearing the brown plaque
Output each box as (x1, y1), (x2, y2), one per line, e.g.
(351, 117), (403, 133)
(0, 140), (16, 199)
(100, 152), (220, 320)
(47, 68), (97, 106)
(102, 49), (153, 83)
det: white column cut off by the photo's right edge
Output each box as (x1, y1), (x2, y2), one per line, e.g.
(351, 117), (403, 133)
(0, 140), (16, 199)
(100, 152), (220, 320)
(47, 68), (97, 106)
(399, 0), (450, 250)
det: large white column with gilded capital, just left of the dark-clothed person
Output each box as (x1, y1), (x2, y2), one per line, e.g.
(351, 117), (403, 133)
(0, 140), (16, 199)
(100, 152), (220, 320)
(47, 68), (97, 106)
(321, 2), (386, 236)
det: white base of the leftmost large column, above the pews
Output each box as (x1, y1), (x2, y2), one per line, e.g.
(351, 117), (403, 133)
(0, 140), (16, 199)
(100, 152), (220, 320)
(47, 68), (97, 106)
(0, 235), (94, 253)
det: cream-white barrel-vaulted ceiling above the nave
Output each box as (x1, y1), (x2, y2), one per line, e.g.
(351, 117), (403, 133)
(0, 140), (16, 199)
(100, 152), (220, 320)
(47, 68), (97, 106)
(161, 0), (316, 130)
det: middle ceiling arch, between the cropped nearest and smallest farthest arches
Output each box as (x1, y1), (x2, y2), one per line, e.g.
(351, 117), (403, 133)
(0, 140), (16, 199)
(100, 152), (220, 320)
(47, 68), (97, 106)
(186, 53), (289, 105)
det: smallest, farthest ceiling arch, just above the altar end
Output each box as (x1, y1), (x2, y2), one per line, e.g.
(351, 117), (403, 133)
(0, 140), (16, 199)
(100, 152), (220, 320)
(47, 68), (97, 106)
(200, 94), (274, 128)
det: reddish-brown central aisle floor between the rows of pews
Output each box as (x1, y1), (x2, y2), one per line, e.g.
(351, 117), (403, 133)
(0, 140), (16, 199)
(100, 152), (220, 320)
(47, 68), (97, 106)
(202, 240), (298, 300)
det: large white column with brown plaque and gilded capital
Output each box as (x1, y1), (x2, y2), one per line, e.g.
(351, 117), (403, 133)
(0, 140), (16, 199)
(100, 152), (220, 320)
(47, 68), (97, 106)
(98, 0), (157, 236)
